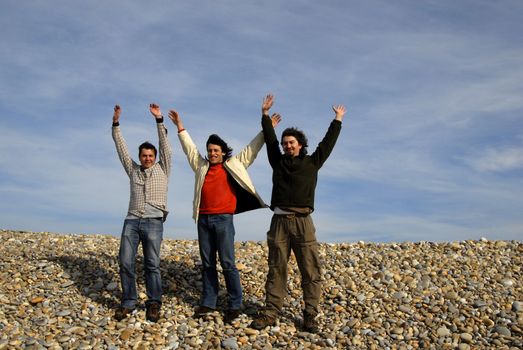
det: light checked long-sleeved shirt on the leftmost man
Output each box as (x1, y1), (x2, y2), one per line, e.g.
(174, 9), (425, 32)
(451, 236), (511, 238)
(112, 119), (172, 219)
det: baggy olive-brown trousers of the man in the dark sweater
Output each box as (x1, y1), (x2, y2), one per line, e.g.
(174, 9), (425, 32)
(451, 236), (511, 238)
(265, 214), (321, 317)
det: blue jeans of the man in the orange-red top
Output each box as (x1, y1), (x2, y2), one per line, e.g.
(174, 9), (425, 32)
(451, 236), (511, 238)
(198, 214), (242, 310)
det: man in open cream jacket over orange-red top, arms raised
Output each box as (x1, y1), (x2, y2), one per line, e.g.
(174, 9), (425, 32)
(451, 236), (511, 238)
(169, 110), (281, 323)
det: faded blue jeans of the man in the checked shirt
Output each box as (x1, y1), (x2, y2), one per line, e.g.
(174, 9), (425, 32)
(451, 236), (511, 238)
(118, 218), (163, 309)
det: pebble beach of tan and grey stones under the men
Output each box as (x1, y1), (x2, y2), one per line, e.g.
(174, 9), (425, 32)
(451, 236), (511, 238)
(0, 230), (523, 350)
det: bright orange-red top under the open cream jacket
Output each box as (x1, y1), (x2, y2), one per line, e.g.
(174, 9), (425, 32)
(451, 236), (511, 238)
(200, 164), (236, 214)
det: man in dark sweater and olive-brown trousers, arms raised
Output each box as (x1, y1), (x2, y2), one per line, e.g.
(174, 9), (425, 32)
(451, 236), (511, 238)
(251, 95), (345, 333)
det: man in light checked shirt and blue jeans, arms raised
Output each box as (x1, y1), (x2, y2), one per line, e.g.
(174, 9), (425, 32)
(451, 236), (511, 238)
(112, 104), (172, 322)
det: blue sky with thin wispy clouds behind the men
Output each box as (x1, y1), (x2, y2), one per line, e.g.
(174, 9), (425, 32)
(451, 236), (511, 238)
(0, 0), (523, 242)
